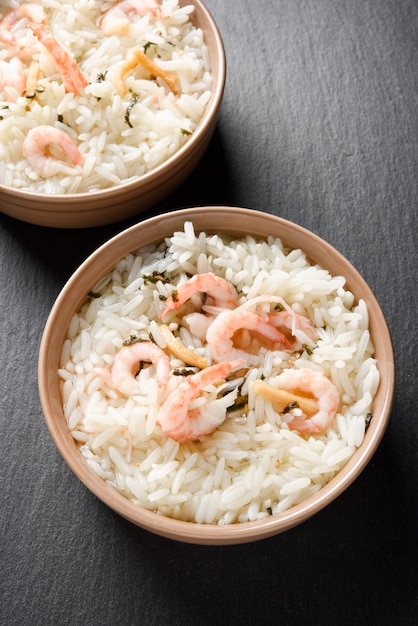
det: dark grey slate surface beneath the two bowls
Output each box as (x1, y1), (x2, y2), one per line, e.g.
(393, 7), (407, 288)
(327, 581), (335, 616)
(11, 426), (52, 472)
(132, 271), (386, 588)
(0, 0), (418, 626)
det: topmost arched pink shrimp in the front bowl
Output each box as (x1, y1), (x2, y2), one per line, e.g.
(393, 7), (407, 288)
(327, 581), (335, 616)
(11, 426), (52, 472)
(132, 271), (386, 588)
(161, 272), (238, 319)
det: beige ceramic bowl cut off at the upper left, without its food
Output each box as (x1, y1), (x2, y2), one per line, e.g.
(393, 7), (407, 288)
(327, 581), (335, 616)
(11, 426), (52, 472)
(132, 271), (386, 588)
(0, 0), (226, 228)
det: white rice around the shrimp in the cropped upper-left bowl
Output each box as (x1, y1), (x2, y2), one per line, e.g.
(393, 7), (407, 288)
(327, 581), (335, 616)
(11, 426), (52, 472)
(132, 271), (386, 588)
(0, 0), (212, 194)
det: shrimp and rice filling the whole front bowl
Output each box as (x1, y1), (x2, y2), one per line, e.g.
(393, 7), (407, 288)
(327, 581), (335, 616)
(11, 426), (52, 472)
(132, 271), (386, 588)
(58, 221), (379, 524)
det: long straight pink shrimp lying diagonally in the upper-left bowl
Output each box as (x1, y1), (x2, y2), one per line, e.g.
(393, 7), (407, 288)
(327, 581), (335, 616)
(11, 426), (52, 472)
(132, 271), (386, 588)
(28, 22), (88, 95)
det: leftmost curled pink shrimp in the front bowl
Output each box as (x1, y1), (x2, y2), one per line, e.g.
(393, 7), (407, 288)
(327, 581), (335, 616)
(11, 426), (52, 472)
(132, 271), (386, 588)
(110, 341), (170, 395)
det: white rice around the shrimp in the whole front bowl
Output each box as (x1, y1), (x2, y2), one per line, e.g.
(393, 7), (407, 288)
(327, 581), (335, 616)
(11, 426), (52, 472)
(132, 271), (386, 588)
(59, 222), (379, 524)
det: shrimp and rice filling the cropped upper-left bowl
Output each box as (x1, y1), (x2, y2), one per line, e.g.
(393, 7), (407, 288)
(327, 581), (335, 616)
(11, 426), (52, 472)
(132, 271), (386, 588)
(0, 0), (212, 194)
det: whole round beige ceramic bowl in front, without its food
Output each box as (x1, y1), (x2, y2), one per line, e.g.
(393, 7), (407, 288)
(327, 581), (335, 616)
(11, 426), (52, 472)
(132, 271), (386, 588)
(39, 207), (395, 544)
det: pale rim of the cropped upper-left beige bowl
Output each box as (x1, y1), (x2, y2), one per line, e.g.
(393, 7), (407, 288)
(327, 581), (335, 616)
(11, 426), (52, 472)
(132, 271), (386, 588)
(0, 0), (226, 207)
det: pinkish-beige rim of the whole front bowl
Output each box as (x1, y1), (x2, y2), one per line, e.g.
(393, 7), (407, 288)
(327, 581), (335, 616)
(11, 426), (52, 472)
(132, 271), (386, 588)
(38, 206), (395, 545)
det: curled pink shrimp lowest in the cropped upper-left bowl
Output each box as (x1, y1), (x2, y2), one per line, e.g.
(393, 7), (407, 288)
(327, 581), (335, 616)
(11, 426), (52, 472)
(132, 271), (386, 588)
(22, 126), (84, 178)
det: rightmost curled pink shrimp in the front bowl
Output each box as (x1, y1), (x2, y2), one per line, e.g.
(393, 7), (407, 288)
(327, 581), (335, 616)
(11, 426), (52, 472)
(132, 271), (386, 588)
(276, 368), (340, 433)
